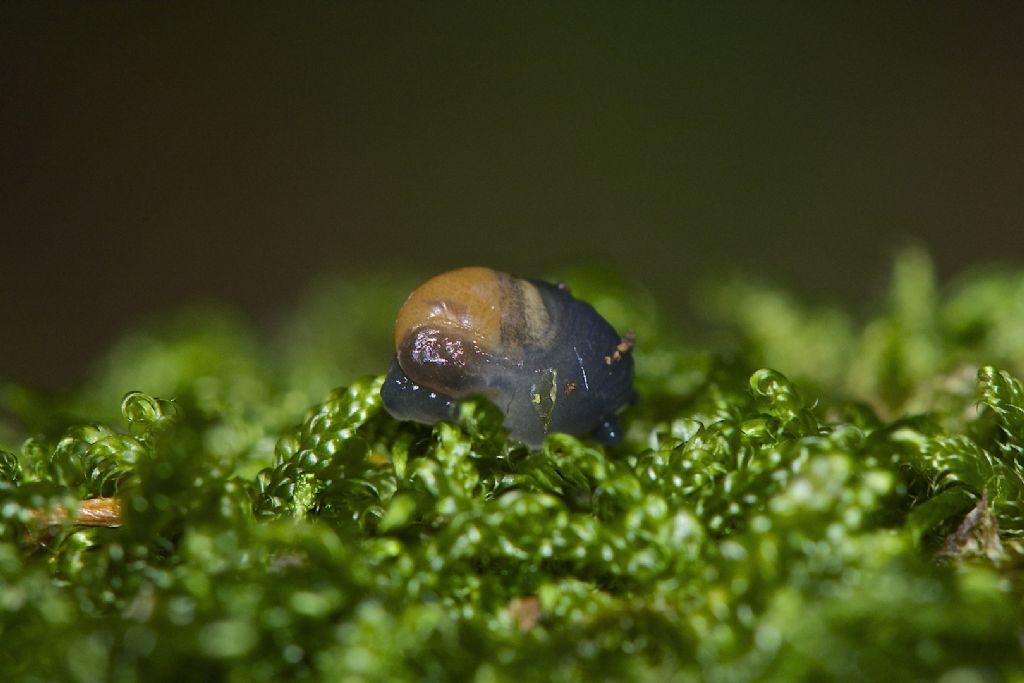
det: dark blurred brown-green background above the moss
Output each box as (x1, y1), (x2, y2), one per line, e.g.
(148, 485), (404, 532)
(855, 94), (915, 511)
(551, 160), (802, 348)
(0, 2), (1024, 387)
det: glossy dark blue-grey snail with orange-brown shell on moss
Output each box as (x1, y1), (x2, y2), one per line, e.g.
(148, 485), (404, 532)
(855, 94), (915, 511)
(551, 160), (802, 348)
(381, 267), (634, 447)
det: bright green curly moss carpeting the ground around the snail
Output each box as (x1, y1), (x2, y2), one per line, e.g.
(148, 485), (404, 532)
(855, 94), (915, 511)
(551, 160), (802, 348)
(0, 252), (1024, 682)
